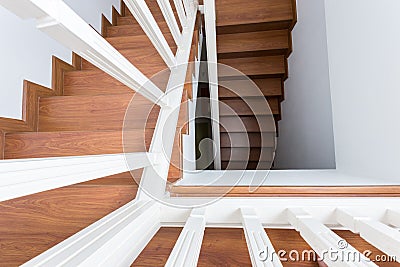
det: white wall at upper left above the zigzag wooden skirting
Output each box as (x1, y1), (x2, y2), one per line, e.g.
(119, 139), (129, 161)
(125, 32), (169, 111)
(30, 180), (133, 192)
(0, 0), (120, 119)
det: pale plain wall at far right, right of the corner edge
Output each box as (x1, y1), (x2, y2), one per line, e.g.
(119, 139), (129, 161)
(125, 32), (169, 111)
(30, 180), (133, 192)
(324, 0), (400, 181)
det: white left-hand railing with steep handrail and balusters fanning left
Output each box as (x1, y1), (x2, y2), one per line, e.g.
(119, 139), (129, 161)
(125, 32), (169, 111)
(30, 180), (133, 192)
(0, 0), (198, 200)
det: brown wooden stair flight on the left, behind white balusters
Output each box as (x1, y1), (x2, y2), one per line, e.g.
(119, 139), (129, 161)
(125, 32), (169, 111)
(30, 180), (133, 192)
(0, 1), (189, 266)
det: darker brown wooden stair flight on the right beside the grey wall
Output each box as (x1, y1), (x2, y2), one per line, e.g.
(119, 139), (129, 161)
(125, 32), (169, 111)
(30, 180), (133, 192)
(216, 0), (296, 170)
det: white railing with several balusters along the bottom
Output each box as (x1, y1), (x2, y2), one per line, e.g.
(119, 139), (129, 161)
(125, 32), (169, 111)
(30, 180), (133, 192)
(23, 197), (400, 267)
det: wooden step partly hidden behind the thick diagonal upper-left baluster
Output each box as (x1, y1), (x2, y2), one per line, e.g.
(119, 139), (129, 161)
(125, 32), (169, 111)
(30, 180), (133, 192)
(82, 47), (170, 80)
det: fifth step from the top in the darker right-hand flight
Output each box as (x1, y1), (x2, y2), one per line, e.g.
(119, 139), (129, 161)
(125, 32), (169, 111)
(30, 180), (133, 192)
(219, 97), (280, 116)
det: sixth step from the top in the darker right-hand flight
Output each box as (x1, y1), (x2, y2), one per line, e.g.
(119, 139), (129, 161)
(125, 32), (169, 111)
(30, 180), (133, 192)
(219, 116), (275, 133)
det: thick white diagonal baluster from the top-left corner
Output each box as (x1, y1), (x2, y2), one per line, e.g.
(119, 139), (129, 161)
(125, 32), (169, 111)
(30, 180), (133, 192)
(0, 0), (166, 105)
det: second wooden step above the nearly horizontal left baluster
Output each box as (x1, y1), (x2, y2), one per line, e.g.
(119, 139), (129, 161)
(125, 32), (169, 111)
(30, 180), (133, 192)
(39, 93), (159, 132)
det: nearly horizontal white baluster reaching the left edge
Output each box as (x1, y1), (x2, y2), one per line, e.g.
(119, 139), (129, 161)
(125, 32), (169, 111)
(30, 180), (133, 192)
(0, 153), (156, 201)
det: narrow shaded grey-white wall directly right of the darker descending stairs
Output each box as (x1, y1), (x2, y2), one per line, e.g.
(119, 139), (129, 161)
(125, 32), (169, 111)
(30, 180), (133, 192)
(275, 0), (335, 169)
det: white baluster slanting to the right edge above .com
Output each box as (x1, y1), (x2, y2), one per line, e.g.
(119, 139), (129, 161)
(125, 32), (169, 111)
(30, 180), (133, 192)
(336, 208), (400, 262)
